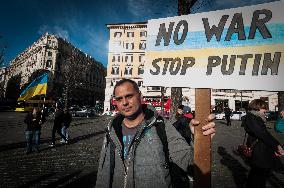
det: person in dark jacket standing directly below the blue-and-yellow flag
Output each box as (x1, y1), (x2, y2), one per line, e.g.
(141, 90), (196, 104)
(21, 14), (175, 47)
(24, 108), (45, 154)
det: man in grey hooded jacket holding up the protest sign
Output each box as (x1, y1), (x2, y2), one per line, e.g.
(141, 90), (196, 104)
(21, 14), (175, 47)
(96, 79), (215, 188)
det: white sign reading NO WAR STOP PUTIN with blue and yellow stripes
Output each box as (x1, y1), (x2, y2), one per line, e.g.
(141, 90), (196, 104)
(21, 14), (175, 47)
(144, 1), (284, 91)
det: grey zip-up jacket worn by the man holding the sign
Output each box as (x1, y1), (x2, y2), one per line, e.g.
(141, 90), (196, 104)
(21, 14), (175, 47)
(96, 105), (193, 188)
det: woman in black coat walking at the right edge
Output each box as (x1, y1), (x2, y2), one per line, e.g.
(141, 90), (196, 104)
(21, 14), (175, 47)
(242, 99), (284, 188)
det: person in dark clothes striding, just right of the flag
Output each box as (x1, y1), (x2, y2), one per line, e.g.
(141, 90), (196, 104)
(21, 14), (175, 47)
(49, 106), (68, 147)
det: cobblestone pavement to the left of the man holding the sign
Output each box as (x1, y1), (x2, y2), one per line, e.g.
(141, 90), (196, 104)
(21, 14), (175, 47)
(0, 113), (108, 187)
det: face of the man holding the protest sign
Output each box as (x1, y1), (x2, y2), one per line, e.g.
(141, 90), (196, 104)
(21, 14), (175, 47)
(115, 82), (141, 117)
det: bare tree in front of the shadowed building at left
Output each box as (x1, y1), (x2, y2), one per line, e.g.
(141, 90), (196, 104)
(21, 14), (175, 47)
(60, 48), (91, 107)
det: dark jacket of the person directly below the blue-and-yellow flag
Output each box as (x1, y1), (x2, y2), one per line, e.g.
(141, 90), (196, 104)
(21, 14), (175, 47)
(24, 112), (45, 131)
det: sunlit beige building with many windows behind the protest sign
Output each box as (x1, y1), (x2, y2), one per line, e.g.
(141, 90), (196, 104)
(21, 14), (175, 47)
(104, 22), (278, 111)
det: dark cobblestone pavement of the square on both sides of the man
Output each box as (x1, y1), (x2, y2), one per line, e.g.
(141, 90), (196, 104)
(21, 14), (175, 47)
(0, 112), (284, 188)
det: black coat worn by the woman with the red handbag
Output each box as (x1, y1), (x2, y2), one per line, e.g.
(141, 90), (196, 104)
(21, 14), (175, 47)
(242, 112), (281, 168)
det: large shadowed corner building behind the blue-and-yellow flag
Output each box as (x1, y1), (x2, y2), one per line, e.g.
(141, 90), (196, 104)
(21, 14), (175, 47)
(2, 33), (106, 105)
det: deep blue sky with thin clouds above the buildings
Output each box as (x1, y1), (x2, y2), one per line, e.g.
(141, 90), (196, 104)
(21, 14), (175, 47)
(0, 0), (272, 67)
